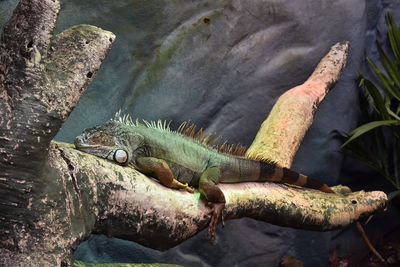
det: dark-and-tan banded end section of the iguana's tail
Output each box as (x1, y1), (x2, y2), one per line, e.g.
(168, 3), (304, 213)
(260, 161), (335, 194)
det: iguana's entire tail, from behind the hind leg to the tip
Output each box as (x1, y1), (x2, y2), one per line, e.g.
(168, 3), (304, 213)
(220, 158), (334, 193)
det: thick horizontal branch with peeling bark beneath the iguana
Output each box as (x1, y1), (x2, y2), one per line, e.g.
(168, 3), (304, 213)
(47, 143), (387, 250)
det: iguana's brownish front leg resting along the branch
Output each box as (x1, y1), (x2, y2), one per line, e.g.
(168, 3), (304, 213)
(136, 157), (194, 193)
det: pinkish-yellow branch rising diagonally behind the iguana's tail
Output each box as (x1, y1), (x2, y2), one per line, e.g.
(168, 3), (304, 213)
(246, 42), (349, 167)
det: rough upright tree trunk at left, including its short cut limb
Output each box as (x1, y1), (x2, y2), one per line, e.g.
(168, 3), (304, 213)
(0, 0), (115, 266)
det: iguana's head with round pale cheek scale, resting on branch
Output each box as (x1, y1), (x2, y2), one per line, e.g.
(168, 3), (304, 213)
(74, 120), (143, 165)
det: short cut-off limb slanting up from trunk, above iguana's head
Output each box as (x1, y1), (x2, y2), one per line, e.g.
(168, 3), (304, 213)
(43, 25), (115, 121)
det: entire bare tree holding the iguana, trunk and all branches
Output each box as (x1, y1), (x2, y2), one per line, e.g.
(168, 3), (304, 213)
(0, 0), (387, 266)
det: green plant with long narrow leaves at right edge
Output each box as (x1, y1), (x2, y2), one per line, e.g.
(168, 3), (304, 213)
(343, 14), (400, 199)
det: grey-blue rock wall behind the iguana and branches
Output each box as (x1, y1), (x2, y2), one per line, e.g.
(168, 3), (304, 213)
(0, 0), (400, 266)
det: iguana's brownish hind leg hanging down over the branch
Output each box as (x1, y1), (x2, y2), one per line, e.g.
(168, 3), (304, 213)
(199, 167), (225, 241)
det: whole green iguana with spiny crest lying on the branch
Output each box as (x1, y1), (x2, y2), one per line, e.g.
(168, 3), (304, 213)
(75, 117), (333, 239)
